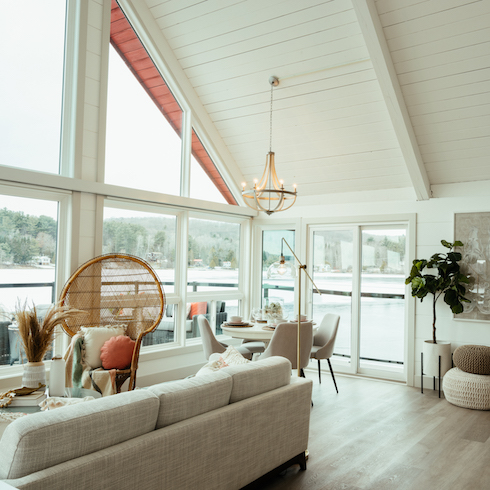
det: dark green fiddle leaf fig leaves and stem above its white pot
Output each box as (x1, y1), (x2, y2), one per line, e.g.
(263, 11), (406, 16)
(405, 240), (471, 344)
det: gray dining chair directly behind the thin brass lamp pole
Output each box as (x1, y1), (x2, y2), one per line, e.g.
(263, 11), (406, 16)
(259, 322), (313, 377)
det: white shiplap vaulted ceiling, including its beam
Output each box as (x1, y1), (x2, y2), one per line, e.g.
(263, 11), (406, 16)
(142, 0), (490, 199)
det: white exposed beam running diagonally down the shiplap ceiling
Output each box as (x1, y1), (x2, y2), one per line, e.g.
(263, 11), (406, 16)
(352, 0), (431, 201)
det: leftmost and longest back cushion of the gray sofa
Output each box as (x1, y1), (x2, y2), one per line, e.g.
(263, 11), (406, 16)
(0, 390), (159, 478)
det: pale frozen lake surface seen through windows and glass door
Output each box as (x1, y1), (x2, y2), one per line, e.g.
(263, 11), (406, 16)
(0, 267), (405, 362)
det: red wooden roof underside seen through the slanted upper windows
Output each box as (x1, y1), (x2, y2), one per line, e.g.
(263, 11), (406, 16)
(111, 0), (237, 205)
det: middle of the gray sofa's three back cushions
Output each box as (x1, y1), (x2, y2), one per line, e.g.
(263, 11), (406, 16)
(148, 371), (232, 429)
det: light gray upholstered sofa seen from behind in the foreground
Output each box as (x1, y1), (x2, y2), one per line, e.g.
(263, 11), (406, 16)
(0, 357), (311, 490)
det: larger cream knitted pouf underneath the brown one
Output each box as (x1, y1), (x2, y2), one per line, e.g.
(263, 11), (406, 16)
(444, 368), (490, 410)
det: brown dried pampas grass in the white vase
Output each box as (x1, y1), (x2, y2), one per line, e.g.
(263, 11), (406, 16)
(15, 304), (86, 362)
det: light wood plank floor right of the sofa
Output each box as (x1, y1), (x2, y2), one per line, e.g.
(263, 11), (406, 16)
(262, 373), (490, 490)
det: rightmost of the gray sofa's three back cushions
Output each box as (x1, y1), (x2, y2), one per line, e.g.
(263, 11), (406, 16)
(224, 356), (292, 403)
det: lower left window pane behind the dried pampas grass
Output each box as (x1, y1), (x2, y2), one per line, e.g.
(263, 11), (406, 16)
(0, 191), (63, 365)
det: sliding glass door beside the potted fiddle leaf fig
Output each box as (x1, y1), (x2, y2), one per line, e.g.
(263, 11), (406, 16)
(309, 224), (407, 379)
